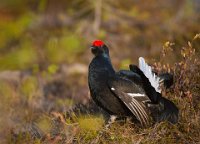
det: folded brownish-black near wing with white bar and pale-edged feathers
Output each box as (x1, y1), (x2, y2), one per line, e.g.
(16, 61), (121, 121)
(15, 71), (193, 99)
(108, 77), (150, 126)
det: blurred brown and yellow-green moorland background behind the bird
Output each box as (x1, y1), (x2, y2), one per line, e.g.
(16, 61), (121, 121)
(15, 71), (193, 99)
(0, 0), (200, 143)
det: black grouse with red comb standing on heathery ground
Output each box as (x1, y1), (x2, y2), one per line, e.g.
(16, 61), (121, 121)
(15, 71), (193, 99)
(88, 40), (179, 126)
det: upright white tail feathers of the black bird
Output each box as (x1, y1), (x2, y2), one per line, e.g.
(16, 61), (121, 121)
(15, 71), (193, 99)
(139, 57), (161, 93)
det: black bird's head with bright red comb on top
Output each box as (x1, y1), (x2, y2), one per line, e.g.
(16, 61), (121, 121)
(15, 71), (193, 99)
(90, 40), (109, 56)
